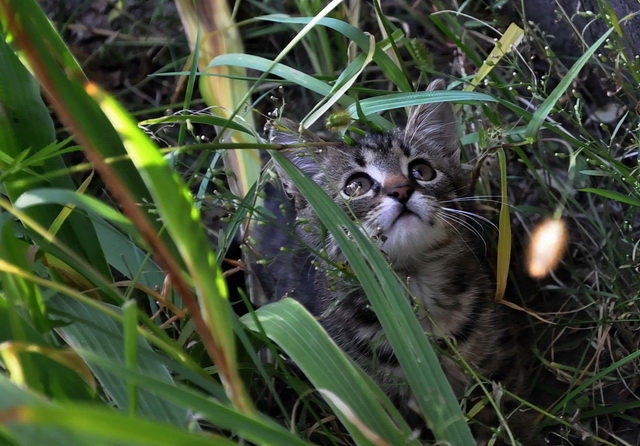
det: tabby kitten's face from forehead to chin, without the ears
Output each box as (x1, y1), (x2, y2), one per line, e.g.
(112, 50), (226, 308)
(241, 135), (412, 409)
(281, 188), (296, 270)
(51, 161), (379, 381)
(318, 130), (464, 264)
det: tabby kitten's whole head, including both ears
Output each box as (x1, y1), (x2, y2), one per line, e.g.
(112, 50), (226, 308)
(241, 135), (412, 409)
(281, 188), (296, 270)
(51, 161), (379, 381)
(269, 80), (465, 267)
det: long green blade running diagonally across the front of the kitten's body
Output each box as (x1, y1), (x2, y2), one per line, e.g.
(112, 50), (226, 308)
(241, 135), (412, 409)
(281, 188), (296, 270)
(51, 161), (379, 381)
(271, 151), (473, 446)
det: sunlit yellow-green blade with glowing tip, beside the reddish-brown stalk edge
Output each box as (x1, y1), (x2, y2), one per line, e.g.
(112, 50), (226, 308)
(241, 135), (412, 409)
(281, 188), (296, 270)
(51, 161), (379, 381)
(92, 88), (252, 411)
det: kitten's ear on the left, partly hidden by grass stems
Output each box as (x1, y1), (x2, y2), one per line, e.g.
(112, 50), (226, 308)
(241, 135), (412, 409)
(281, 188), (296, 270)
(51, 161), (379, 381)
(265, 118), (322, 194)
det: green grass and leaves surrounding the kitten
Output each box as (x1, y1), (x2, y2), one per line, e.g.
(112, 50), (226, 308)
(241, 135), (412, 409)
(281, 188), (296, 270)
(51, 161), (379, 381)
(0, 0), (640, 445)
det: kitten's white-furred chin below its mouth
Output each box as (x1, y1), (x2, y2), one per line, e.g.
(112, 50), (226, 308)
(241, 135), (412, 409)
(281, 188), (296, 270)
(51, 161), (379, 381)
(381, 214), (445, 266)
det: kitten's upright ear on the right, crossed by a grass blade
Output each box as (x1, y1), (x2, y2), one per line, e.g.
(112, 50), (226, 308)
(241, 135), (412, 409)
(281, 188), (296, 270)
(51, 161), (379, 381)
(404, 79), (460, 163)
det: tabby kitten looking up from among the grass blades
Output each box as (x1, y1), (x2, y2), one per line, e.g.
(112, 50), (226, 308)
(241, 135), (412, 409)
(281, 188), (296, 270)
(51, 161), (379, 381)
(252, 81), (521, 440)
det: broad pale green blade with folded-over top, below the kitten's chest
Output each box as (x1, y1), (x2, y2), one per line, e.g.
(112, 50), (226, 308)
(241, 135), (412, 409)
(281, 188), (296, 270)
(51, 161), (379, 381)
(242, 299), (410, 444)
